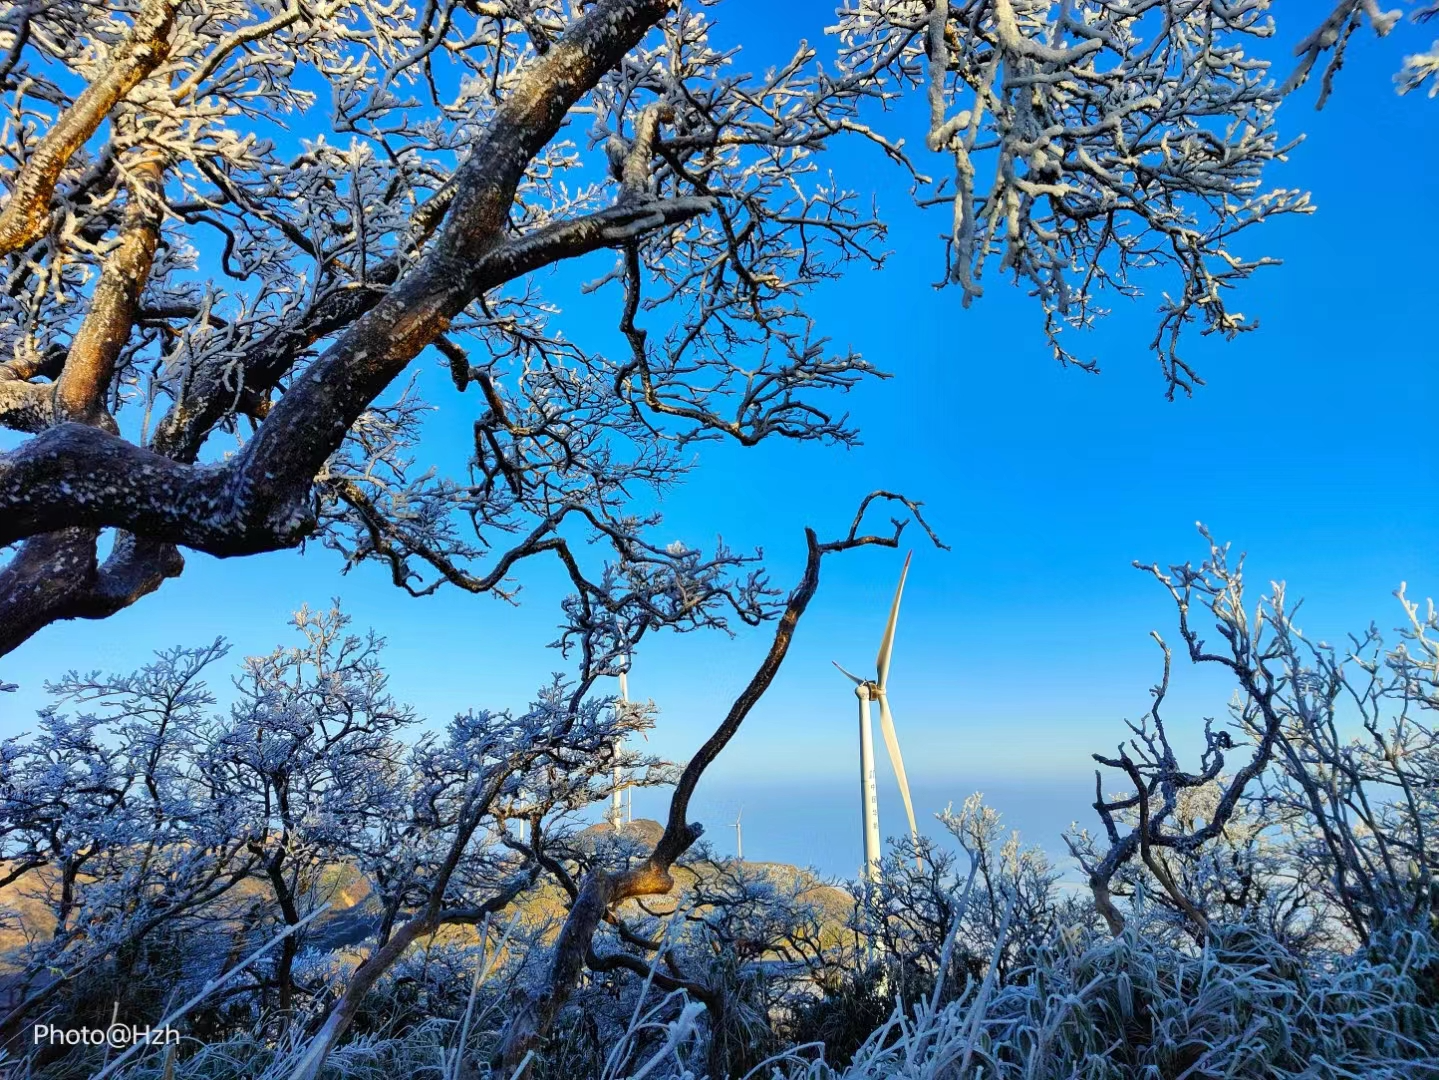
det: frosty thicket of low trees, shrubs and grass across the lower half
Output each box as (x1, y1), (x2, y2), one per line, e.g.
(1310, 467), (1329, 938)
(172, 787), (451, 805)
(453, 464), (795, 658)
(0, 529), (1439, 1080)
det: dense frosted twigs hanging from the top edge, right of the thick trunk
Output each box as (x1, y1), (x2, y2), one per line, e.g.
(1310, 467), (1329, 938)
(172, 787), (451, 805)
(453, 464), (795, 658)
(839, 0), (1309, 395)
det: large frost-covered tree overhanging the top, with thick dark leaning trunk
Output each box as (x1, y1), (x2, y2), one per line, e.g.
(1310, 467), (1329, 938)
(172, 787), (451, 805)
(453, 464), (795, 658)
(0, 0), (1433, 655)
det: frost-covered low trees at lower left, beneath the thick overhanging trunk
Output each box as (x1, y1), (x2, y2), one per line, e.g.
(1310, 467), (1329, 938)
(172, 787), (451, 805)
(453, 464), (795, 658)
(0, 610), (663, 1064)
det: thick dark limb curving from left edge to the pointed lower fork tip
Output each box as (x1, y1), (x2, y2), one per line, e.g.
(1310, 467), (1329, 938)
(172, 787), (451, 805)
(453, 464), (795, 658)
(0, 198), (709, 555)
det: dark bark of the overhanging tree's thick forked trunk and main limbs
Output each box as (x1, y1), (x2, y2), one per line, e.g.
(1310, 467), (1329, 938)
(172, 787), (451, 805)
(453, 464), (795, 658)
(0, 0), (696, 651)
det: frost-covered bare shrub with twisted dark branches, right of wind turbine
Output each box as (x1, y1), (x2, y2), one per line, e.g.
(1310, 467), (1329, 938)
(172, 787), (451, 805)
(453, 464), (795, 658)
(1069, 534), (1439, 941)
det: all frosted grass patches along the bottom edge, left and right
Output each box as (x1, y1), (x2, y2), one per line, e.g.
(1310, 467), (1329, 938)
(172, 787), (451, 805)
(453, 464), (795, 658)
(75, 916), (1439, 1080)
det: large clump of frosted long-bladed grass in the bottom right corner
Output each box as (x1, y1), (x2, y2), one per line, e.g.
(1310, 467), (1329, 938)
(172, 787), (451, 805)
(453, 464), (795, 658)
(811, 920), (1439, 1080)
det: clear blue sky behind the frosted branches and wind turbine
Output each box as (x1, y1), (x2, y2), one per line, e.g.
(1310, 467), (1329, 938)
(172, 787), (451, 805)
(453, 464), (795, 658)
(0, 0), (1439, 870)
